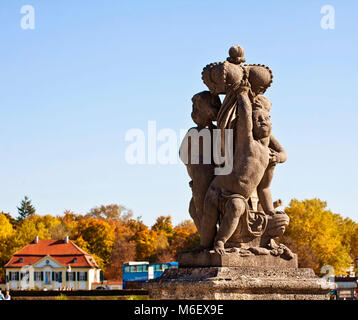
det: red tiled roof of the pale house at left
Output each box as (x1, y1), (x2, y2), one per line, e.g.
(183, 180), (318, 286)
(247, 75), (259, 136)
(5, 240), (98, 268)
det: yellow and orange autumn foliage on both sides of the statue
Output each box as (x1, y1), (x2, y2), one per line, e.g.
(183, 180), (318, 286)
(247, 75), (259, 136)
(0, 199), (358, 276)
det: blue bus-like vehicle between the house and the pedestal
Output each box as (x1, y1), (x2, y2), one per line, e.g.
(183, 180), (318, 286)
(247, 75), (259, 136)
(123, 261), (179, 289)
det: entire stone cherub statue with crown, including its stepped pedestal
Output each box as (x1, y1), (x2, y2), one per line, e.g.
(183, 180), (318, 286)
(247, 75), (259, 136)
(145, 46), (335, 300)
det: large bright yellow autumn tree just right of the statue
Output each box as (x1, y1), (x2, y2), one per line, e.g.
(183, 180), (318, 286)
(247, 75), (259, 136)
(283, 199), (352, 274)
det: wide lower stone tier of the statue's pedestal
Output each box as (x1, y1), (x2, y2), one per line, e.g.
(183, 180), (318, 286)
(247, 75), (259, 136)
(146, 267), (334, 300)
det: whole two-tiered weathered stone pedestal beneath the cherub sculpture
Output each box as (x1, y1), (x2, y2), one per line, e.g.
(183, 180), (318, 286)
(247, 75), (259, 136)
(146, 250), (335, 300)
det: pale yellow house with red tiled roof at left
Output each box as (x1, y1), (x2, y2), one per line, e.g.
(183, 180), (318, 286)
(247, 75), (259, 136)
(5, 237), (100, 290)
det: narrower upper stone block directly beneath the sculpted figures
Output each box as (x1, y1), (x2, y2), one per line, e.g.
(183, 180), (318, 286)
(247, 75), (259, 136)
(178, 250), (298, 268)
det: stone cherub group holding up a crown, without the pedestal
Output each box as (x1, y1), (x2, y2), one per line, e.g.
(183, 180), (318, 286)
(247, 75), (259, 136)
(181, 46), (292, 259)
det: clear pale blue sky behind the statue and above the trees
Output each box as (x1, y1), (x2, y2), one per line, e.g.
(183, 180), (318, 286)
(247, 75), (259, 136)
(0, 0), (358, 224)
